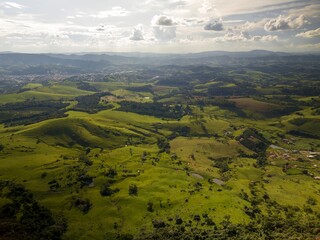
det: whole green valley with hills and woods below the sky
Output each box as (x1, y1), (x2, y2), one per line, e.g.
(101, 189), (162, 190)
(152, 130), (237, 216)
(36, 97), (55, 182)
(0, 53), (320, 240)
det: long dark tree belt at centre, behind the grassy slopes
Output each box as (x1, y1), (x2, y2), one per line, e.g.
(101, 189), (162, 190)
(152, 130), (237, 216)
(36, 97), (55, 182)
(118, 101), (191, 119)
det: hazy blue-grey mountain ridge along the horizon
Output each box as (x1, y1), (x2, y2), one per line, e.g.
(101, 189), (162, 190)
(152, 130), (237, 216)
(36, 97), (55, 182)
(0, 50), (320, 74)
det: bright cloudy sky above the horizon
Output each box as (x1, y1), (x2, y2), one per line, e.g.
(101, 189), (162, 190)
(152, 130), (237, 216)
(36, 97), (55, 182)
(0, 0), (320, 53)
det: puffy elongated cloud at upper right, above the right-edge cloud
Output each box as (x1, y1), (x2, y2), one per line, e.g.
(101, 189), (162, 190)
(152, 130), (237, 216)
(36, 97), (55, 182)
(264, 15), (308, 32)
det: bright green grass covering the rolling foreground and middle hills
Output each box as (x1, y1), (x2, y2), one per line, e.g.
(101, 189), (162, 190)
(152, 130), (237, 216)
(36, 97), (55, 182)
(0, 82), (320, 239)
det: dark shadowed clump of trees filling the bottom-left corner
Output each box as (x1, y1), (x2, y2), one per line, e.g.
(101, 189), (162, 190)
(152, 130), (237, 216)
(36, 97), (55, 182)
(0, 180), (67, 240)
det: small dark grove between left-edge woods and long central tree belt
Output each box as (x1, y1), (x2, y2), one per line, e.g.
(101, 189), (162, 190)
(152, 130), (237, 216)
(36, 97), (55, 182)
(72, 92), (111, 114)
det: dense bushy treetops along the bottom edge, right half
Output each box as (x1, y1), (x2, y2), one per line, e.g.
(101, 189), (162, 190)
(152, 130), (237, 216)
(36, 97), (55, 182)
(133, 210), (320, 240)
